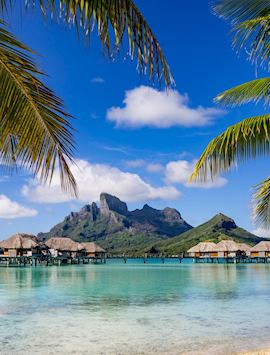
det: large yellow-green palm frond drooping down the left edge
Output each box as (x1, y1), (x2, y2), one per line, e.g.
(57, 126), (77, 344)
(0, 22), (76, 194)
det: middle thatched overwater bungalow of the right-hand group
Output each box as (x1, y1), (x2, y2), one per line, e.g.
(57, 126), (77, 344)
(215, 240), (250, 258)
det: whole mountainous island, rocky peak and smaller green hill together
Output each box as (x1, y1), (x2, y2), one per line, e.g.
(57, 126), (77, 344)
(38, 193), (264, 256)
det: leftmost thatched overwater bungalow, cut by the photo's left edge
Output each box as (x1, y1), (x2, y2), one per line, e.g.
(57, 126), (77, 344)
(0, 233), (42, 258)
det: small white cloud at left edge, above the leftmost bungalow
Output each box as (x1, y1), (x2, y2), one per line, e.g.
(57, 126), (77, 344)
(0, 195), (37, 219)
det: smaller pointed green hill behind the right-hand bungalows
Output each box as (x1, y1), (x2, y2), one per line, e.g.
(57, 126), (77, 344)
(154, 213), (263, 255)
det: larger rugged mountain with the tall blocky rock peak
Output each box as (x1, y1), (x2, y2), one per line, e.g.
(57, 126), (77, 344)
(38, 193), (192, 255)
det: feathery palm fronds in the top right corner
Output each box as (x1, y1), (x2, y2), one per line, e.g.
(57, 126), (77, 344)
(214, 0), (270, 66)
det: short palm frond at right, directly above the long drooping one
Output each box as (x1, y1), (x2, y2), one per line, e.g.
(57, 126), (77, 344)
(215, 78), (270, 106)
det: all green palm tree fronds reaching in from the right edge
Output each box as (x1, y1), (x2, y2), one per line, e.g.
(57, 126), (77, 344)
(190, 0), (270, 228)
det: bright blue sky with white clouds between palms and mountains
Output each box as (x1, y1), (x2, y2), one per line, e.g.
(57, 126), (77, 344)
(0, 0), (268, 239)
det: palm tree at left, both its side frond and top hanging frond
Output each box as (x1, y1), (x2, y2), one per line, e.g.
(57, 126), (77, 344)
(0, 0), (173, 194)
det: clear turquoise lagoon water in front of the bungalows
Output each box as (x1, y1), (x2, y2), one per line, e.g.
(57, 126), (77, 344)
(0, 259), (270, 354)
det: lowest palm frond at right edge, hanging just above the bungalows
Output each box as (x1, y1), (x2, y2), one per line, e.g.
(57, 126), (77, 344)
(253, 177), (270, 228)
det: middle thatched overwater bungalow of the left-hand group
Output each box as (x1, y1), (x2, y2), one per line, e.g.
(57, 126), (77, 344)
(45, 237), (84, 258)
